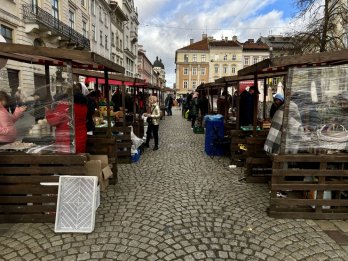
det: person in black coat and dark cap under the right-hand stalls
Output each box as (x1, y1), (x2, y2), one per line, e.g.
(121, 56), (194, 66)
(239, 86), (260, 126)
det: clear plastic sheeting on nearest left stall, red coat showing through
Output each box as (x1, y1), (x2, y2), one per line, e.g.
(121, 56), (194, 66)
(0, 82), (75, 154)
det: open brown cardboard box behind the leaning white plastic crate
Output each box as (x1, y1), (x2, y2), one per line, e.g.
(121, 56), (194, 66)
(85, 155), (113, 191)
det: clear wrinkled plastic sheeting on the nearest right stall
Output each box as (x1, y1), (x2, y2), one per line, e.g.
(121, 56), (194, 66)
(282, 65), (348, 153)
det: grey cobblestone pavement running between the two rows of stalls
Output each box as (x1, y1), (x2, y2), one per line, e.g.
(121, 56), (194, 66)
(0, 109), (348, 261)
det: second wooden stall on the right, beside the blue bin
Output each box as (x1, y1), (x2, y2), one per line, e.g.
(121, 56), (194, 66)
(216, 72), (286, 183)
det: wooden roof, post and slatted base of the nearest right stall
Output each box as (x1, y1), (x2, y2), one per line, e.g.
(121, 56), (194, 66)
(239, 49), (348, 219)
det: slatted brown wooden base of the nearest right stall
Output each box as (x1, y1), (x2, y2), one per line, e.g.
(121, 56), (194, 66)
(269, 154), (348, 219)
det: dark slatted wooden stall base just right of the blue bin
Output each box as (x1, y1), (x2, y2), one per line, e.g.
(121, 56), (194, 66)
(231, 130), (272, 183)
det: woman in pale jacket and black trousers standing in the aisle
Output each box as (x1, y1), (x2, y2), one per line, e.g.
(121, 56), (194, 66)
(144, 96), (161, 150)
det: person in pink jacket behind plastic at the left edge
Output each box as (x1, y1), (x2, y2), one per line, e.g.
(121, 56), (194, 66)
(0, 91), (26, 144)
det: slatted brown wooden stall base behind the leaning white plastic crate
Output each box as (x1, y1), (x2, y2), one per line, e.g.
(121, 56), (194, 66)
(0, 153), (87, 223)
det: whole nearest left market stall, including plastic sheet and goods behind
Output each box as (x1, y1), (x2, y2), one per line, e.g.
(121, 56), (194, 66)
(0, 43), (124, 223)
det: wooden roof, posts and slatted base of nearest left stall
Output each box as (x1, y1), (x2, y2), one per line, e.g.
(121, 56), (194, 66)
(0, 43), (124, 223)
